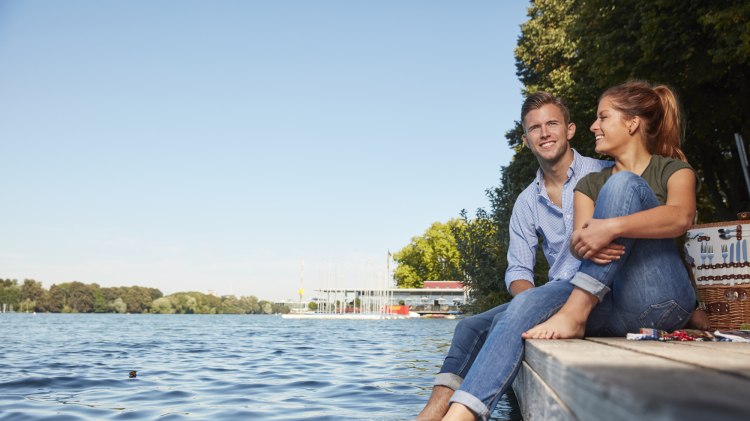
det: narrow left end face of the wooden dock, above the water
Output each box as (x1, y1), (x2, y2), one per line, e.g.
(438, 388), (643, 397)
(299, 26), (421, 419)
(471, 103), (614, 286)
(513, 362), (577, 421)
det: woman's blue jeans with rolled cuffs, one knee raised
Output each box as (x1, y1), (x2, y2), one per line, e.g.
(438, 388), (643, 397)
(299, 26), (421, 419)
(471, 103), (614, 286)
(450, 172), (695, 420)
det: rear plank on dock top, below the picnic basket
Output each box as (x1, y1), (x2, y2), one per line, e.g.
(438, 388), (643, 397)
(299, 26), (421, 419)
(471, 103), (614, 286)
(587, 338), (750, 380)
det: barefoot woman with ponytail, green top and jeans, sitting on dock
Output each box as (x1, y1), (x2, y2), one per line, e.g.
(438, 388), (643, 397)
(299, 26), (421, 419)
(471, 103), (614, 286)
(443, 81), (695, 420)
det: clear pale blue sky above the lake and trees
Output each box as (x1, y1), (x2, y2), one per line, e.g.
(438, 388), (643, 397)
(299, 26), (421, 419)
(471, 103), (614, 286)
(0, 0), (528, 300)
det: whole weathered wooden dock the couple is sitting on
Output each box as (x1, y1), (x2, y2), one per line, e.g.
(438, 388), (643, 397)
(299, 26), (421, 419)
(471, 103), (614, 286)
(513, 338), (750, 421)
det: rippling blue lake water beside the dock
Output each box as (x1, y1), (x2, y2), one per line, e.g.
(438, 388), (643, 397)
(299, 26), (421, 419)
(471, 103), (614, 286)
(0, 313), (520, 420)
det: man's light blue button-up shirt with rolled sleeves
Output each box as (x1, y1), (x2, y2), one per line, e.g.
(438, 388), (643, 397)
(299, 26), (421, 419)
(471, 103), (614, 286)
(505, 149), (613, 291)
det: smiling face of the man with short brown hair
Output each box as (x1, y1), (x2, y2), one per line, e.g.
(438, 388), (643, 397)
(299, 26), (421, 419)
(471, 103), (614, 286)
(523, 104), (576, 164)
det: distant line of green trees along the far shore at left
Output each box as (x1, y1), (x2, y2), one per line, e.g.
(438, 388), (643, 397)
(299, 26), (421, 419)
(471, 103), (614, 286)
(0, 279), (289, 314)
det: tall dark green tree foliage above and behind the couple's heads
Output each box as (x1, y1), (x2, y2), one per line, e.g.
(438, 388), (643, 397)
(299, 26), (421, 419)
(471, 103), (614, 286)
(507, 0), (750, 222)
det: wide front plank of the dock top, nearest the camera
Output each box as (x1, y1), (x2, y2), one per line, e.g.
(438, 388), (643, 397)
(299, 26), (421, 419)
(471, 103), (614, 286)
(526, 340), (750, 421)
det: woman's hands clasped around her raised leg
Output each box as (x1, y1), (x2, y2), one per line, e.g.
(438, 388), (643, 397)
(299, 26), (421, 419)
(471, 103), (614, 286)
(570, 219), (625, 265)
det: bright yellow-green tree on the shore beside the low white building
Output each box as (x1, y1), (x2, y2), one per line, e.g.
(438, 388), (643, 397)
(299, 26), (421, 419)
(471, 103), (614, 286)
(393, 219), (463, 288)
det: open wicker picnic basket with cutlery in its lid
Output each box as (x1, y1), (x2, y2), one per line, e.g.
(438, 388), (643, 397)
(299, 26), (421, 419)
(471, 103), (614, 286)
(685, 220), (750, 330)
